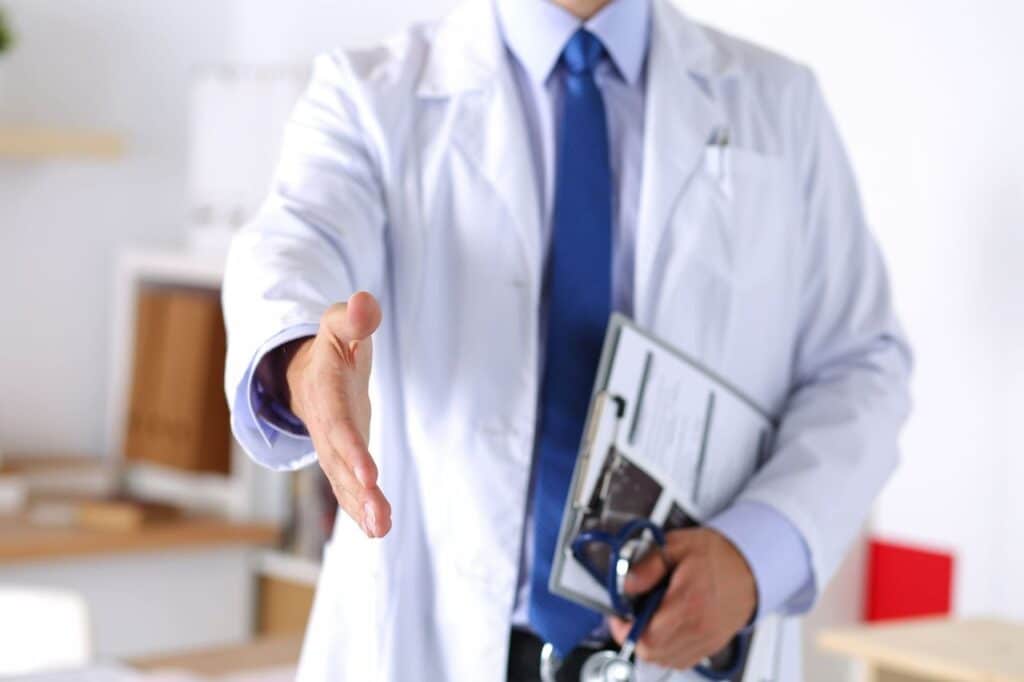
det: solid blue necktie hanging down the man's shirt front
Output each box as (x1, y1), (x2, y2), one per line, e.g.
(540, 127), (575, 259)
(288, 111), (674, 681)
(529, 29), (611, 655)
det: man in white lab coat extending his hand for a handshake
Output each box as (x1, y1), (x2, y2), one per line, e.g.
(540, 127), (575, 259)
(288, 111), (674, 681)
(223, 0), (910, 682)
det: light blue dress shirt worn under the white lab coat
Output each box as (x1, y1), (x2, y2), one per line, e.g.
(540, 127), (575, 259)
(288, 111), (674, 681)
(243, 0), (814, 627)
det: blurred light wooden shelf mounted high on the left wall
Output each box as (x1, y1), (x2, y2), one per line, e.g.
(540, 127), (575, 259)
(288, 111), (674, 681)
(0, 125), (124, 161)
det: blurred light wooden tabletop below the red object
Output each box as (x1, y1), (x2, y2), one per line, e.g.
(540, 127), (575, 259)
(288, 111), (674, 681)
(818, 620), (1024, 682)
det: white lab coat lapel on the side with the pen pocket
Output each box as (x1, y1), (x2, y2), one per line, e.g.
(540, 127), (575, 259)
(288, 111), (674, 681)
(634, 0), (730, 326)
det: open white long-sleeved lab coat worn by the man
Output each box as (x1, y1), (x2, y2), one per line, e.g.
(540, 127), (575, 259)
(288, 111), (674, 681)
(224, 0), (909, 682)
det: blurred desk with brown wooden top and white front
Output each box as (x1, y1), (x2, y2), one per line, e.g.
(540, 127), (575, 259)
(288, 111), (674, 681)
(0, 517), (278, 659)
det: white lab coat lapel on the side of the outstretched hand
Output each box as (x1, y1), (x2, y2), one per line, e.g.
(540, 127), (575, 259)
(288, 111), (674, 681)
(419, 0), (542, 288)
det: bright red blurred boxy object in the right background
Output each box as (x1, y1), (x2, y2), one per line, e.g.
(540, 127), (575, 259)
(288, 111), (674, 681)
(864, 540), (953, 622)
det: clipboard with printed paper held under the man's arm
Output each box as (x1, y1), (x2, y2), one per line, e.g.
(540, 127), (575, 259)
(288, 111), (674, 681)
(550, 314), (774, 613)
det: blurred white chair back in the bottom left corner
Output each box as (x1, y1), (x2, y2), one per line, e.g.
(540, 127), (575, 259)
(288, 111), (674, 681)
(0, 586), (91, 677)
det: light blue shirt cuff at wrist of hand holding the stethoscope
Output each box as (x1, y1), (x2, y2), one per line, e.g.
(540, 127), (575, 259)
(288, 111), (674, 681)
(706, 502), (814, 620)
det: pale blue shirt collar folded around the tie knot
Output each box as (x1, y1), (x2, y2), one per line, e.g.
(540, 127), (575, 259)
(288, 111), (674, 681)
(494, 0), (650, 85)
